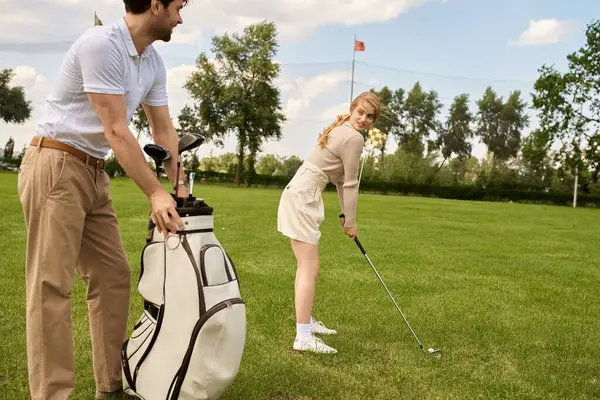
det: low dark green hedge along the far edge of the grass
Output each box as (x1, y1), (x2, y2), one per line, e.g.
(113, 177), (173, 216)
(195, 171), (600, 207)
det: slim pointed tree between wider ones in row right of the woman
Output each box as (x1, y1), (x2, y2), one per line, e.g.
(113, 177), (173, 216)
(435, 94), (473, 169)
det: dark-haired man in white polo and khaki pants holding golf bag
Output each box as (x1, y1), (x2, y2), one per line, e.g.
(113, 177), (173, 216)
(18, 0), (189, 400)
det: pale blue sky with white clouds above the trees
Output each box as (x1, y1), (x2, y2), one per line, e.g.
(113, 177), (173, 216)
(0, 0), (600, 159)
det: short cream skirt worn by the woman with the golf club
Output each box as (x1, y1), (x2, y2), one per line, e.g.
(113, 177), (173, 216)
(277, 161), (329, 245)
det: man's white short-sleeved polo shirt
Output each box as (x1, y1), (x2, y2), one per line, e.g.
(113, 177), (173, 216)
(36, 18), (168, 158)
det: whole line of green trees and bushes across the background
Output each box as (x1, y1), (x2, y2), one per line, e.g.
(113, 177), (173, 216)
(0, 20), (600, 206)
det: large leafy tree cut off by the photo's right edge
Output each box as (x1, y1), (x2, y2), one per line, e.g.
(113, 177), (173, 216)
(533, 20), (600, 183)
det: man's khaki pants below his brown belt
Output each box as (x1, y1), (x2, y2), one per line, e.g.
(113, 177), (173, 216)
(18, 146), (130, 400)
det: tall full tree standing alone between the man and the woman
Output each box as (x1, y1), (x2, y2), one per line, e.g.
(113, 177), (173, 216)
(184, 22), (285, 185)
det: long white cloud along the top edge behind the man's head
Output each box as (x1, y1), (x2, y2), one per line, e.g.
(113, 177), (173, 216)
(0, 0), (444, 44)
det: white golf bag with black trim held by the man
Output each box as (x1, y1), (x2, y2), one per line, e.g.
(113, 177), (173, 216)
(121, 198), (246, 400)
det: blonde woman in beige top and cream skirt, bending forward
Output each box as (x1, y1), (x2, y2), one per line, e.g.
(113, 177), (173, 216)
(277, 92), (380, 353)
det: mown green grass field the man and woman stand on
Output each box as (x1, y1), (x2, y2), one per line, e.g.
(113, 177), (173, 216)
(0, 173), (600, 400)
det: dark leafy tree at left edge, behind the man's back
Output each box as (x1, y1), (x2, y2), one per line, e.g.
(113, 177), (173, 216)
(0, 69), (32, 124)
